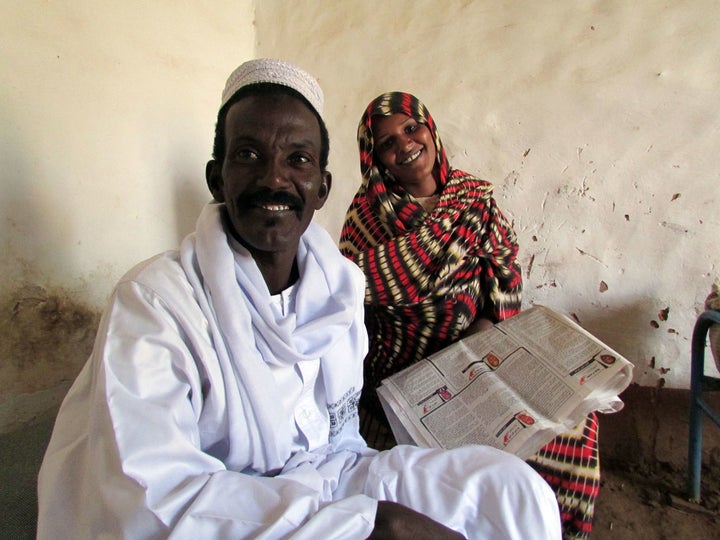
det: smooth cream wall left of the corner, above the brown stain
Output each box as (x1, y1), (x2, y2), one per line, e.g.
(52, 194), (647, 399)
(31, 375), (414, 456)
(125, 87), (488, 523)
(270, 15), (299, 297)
(0, 0), (255, 307)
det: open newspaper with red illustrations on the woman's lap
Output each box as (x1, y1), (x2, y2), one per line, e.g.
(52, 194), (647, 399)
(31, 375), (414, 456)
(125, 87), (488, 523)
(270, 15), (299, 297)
(378, 305), (633, 459)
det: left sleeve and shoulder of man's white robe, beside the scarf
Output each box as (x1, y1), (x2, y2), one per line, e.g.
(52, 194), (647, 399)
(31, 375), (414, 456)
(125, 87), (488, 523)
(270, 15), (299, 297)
(38, 261), (377, 539)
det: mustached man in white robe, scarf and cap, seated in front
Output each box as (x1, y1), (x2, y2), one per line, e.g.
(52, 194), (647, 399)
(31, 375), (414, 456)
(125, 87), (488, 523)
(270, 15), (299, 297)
(38, 60), (560, 539)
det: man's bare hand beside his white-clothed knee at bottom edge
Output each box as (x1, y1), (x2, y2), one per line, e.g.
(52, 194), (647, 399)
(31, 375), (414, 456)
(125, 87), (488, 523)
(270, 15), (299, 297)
(368, 501), (465, 540)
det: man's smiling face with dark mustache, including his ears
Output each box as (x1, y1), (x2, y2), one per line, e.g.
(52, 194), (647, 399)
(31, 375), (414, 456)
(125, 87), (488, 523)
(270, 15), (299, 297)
(207, 95), (331, 258)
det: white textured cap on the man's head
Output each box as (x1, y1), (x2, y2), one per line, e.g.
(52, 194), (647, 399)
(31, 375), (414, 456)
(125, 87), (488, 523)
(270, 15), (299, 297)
(220, 58), (323, 117)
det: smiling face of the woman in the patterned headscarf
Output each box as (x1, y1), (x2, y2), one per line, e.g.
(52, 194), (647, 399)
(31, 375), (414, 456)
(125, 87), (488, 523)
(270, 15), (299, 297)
(372, 113), (437, 197)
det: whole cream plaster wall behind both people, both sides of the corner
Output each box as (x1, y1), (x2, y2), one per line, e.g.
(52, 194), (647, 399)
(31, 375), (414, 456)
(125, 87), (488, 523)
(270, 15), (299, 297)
(0, 0), (720, 398)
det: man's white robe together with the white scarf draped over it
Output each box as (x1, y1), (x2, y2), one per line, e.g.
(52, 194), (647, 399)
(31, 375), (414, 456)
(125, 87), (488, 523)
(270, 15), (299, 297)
(38, 203), (560, 540)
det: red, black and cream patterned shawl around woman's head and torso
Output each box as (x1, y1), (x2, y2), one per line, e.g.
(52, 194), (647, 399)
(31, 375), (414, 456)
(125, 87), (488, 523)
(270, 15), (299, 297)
(340, 92), (522, 400)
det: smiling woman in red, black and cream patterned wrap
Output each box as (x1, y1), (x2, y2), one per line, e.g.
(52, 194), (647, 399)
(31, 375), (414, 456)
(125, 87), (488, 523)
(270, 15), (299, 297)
(340, 92), (600, 538)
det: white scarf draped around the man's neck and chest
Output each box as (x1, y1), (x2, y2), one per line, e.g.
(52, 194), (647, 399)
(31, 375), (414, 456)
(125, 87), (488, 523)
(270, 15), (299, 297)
(180, 203), (367, 472)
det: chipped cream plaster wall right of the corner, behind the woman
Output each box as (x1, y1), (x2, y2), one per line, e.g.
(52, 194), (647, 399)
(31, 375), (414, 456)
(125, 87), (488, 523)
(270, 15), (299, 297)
(256, 0), (720, 387)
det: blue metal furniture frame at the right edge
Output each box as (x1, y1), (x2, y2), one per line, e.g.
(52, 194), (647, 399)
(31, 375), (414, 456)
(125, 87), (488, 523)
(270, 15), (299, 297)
(687, 310), (720, 502)
